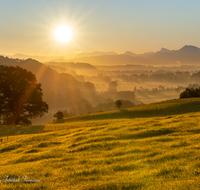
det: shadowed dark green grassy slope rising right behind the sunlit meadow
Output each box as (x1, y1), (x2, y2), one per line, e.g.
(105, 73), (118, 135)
(52, 98), (200, 123)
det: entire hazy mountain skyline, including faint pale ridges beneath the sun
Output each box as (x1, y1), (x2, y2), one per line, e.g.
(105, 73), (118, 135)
(6, 45), (200, 66)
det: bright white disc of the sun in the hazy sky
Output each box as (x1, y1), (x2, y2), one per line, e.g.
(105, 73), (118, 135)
(54, 25), (73, 43)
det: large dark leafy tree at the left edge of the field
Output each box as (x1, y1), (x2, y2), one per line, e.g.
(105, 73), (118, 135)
(0, 65), (48, 125)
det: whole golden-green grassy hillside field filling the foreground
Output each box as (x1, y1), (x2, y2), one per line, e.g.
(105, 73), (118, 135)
(0, 98), (200, 190)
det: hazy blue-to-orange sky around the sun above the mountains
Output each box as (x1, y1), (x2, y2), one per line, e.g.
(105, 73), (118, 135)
(0, 0), (200, 56)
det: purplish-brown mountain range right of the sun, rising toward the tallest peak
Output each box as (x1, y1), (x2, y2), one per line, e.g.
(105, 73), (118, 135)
(68, 45), (200, 66)
